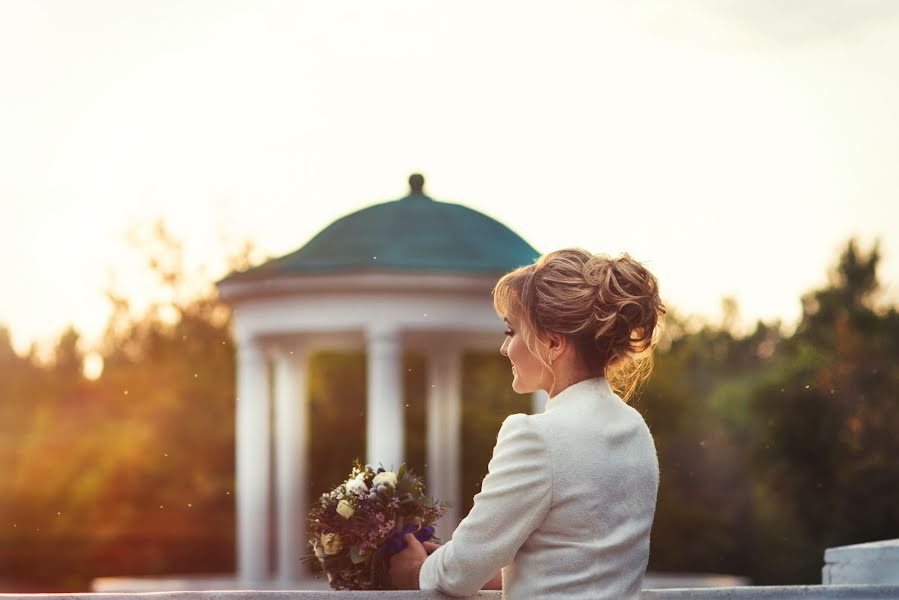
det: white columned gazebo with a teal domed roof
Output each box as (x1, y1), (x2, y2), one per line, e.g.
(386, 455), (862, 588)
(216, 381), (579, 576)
(218, 174), (544, 586)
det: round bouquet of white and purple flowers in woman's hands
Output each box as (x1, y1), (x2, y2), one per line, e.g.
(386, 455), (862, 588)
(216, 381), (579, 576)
(301, 460), (446, 590)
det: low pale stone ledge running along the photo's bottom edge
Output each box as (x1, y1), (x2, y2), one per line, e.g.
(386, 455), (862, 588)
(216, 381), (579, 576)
(0, 585), (899, 600)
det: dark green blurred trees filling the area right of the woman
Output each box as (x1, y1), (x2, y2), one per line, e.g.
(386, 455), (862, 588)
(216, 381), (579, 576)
(636, 241), (899, 583)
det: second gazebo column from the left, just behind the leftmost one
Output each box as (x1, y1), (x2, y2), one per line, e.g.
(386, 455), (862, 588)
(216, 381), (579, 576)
(275, 345), (309, 584)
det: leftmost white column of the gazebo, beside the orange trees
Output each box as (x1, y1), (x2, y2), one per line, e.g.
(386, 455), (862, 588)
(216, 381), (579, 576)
(236, 339), (271, 589)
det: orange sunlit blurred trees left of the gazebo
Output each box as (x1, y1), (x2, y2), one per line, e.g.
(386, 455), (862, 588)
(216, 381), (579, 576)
(0, 223), (260, 591)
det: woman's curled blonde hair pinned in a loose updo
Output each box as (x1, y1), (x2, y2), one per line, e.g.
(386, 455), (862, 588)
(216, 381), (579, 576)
(493, 248), (665, 401)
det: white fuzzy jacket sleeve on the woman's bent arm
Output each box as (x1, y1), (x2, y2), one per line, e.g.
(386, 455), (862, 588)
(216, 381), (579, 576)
(419, 414), (552, 596)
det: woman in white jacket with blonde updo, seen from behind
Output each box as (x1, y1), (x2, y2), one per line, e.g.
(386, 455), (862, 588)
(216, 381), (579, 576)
(390, 249), (664, 599)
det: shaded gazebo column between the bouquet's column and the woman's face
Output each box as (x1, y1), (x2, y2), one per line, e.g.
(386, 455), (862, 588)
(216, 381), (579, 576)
(425, 348), (462, 542)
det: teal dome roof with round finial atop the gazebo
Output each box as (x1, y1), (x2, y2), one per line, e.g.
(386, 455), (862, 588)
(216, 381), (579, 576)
(227, 175), (539, 280)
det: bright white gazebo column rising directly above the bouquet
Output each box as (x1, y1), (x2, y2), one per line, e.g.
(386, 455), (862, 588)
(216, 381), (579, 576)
(366, 327), (405, 470)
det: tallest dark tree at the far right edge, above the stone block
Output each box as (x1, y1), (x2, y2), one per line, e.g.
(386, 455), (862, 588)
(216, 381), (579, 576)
(752, 240), (899, 581)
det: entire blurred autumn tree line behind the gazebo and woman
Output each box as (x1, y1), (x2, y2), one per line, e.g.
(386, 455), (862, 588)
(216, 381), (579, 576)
(0, 231), (899, 591)
